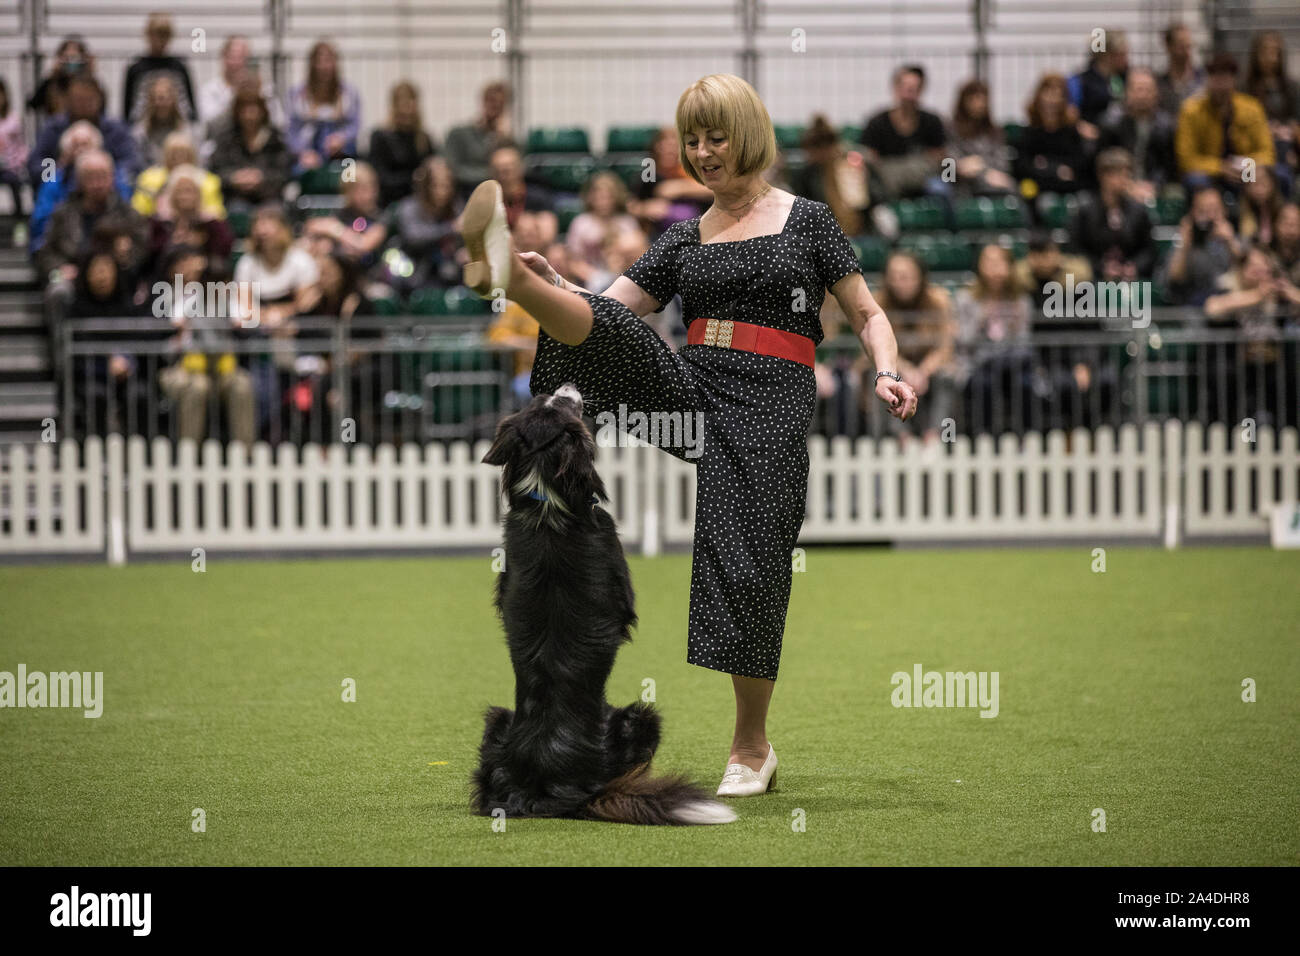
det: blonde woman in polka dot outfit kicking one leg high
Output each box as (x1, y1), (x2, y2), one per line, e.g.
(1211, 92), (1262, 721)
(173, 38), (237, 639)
(462, 74), (917, 796)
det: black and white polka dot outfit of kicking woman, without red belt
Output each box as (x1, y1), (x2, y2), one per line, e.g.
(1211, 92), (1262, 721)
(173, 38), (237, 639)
(530, 196), (862, 680)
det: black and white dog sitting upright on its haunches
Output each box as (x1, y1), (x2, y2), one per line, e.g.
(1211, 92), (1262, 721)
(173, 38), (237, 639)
(472, 385), (736, 825)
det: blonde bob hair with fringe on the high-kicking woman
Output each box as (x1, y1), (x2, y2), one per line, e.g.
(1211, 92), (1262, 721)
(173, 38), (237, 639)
(677, 73), (776, 186)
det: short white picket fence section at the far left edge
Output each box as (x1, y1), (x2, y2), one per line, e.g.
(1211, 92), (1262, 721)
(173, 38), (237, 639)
(0, 438), (104, 554)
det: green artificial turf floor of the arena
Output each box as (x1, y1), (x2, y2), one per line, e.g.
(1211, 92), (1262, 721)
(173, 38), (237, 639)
(0, 546), (1300, 865)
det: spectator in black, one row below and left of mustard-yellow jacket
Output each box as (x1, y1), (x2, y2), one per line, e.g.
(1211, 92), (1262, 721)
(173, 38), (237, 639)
(1074, 147), (1156, 282)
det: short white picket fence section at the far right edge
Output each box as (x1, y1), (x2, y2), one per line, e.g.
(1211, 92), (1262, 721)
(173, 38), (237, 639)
(1183, 421), (1300, 537)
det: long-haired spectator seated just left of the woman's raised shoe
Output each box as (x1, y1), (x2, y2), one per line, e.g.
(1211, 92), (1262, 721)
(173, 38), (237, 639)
(384, 156), (465, 297)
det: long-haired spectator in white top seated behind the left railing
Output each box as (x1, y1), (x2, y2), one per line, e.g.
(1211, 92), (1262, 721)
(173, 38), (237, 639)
(234, 204), (320, 442)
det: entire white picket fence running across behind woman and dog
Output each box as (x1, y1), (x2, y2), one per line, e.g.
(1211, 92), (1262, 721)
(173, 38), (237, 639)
(0, 421), (1300, 561)
